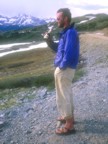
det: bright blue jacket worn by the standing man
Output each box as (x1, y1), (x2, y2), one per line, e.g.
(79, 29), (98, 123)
(47, 26), (79, 69)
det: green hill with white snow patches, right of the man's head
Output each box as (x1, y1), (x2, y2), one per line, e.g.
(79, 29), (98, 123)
(73, 14), (108, 31)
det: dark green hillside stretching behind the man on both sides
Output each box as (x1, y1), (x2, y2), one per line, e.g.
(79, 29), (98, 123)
(0, 14), (108, 43)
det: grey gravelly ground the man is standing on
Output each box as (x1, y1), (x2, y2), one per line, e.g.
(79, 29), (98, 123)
(0, 34), (108, 144)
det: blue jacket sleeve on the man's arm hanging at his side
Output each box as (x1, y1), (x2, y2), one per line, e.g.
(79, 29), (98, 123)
(59, 30), (79, 69)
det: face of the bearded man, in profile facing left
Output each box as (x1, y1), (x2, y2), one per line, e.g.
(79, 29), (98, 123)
(56, 12), (64, 28)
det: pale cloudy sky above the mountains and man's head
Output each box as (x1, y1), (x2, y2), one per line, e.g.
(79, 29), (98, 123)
(0, 0), (108, 18)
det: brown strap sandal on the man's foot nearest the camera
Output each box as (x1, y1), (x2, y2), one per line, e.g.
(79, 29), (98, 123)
(56, 127), (76, 135)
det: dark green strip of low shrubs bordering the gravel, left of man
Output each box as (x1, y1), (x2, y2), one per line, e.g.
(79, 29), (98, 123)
(0, 74), (54, 89)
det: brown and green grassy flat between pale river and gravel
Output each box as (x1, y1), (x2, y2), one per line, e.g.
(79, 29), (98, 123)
(0, 48), (83, 89)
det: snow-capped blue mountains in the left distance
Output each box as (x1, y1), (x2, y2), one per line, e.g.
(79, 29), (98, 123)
(0, 14), (47, 31)
